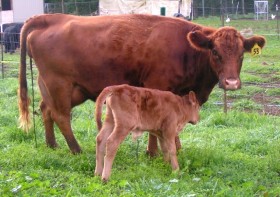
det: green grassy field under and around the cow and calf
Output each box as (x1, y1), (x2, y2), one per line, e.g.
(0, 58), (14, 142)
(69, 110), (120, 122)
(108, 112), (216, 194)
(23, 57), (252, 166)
(0, 18), (280, 197)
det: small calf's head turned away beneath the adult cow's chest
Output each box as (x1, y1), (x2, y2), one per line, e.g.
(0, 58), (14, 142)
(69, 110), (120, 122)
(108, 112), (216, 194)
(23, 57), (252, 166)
(186, 91), (200, 124)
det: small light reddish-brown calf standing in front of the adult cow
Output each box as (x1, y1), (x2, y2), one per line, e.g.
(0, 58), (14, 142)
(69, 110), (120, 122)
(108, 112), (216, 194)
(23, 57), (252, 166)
(95, 85), (199, 181)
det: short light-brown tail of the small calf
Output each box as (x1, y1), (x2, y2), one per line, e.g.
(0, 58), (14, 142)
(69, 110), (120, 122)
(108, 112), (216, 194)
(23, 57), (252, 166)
(95, 87), (113, 131)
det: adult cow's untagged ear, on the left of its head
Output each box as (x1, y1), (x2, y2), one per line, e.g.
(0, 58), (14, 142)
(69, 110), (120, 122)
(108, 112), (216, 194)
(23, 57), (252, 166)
(187, 30), (212, 51)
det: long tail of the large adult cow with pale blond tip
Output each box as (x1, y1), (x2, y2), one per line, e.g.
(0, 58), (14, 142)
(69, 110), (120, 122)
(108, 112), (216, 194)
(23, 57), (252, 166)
(18, 16), (46, 132)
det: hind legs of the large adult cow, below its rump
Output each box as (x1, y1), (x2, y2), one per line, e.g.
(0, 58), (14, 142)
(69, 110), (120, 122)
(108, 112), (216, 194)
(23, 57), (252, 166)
(38, 76), (81, 154)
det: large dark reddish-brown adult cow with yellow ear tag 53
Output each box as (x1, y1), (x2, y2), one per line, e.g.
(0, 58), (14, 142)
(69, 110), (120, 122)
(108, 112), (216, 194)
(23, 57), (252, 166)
(19, 14), (265, 155)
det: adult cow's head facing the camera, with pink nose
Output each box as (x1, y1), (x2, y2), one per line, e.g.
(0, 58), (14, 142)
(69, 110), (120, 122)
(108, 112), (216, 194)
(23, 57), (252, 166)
(187, 27), (265, 90)
